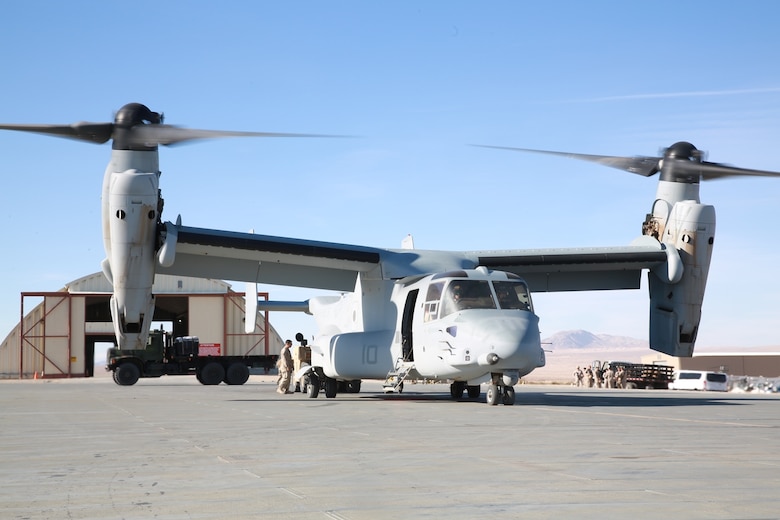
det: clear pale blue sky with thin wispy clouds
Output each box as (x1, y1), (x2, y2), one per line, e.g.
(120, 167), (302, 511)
(0, 0), (780, 349)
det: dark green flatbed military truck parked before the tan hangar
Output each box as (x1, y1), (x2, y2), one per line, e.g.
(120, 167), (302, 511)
(106, 330), (278, 386)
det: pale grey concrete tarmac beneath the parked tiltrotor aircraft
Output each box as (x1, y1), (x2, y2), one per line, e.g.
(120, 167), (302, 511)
(0, 376), (780, 520)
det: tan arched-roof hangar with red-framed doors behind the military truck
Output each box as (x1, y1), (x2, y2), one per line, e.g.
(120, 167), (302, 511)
(0, 272), (282, 379)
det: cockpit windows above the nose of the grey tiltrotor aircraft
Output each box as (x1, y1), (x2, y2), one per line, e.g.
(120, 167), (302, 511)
(424, 272), (533, 321)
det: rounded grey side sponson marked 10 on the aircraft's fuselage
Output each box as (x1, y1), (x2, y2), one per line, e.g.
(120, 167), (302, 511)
(312, 330), (394, 379)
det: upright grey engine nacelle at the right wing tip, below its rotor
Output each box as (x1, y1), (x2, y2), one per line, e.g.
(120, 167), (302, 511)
(645, 199), (715, 357)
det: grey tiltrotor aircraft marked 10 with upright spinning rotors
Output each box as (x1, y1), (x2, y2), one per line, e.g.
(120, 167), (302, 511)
(0, 103), (780, 405)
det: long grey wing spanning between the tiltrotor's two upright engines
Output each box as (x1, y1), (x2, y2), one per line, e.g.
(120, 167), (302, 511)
(158, 223), (669, 292)
